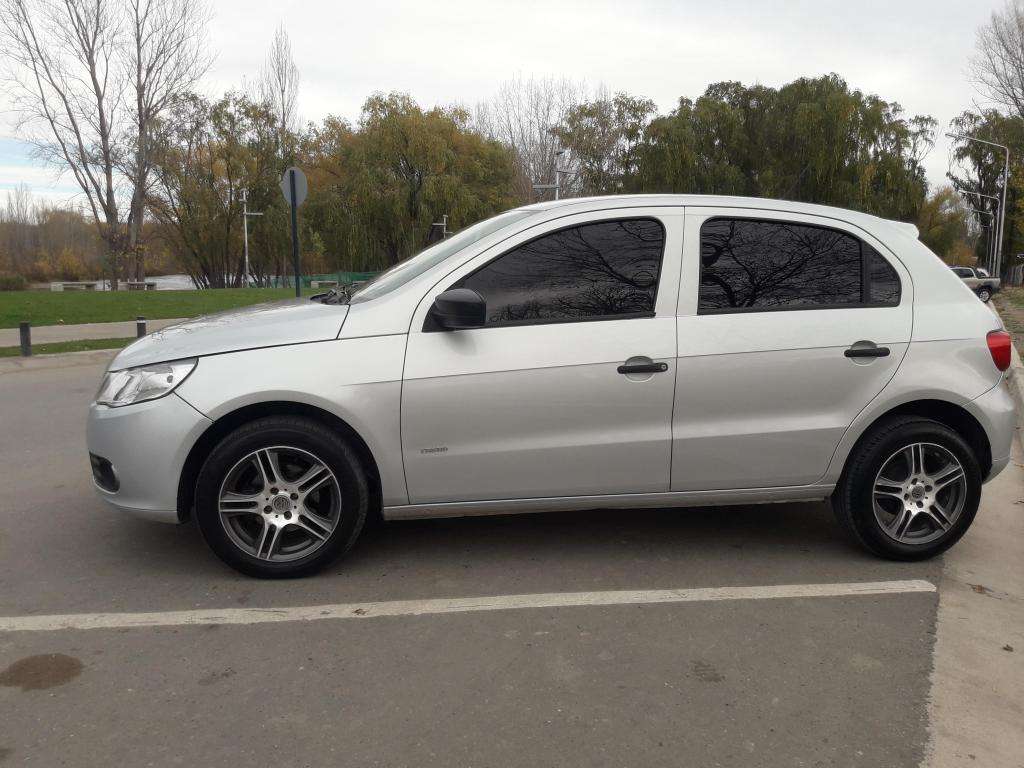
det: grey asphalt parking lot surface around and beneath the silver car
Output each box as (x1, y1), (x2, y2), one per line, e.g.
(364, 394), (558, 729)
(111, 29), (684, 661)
(0, 357), (1024, 768)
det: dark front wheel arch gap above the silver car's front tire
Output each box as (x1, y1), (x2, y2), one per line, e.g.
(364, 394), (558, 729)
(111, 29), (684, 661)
(177, 400), (383, 522)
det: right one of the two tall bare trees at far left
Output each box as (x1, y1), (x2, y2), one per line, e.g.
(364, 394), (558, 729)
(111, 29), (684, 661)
(122, 0), (213, 280)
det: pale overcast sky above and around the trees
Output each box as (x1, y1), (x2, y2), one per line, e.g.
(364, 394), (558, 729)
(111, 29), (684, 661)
(0, 0), (1004, 202)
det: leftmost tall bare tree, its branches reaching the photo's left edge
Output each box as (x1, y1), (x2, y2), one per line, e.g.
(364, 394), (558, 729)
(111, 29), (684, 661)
(0, 0), (124, 287)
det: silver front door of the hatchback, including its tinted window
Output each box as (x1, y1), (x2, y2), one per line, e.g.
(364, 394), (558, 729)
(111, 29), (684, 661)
(401, 208), (683, 504)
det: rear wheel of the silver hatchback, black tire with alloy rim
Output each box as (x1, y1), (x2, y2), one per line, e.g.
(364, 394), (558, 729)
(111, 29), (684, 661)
(833, 417), (982, 560)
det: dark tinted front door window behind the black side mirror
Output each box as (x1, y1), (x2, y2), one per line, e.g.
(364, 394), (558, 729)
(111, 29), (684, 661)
(456, 219), (665, 325)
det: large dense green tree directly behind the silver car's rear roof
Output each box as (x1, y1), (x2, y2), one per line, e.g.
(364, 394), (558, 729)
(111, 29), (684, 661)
(626, 75), (936, 221)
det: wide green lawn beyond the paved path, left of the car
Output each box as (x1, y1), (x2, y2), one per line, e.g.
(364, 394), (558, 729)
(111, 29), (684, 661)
(0, 288), (295, 328)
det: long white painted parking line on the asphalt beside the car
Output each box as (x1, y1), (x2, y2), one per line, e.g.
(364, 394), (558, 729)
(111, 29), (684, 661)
(0, 580), (936, 632)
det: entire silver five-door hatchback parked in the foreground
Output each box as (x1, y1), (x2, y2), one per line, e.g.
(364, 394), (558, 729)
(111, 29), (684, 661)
(88, 196), (1014, 577)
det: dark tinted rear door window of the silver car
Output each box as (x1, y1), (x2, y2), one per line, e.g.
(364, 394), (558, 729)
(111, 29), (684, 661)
(698, 218), (900, 313)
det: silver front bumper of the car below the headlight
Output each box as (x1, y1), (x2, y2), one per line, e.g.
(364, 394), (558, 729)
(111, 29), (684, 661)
(86, 392), (211, 522)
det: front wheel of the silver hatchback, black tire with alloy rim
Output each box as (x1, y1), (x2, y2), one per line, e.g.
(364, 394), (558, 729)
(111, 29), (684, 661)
(196, 416), (370, 579)
